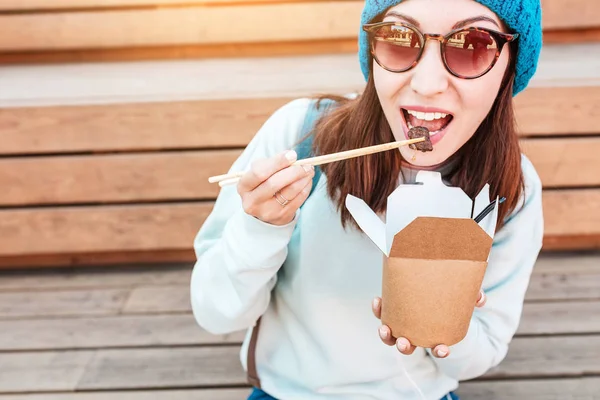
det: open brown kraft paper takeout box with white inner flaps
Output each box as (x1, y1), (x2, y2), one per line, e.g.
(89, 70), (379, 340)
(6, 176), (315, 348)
(346, 171), (498, 348)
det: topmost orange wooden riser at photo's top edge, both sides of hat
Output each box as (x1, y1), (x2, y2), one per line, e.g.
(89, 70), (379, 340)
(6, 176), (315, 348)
(0, 0), (600, 62)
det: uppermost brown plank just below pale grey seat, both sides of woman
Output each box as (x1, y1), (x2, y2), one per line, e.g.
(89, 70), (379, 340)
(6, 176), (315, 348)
(0, 87), (600, 155)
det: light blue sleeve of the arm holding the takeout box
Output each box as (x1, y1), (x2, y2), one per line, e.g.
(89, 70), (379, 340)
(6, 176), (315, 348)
(428, 156), (544, 380)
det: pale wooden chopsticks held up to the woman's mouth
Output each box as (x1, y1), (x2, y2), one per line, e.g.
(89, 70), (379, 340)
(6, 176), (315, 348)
(208, 137), (425, 187)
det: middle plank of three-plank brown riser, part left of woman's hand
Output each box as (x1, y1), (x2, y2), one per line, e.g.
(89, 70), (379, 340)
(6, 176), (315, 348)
(0, 150), (239, 206)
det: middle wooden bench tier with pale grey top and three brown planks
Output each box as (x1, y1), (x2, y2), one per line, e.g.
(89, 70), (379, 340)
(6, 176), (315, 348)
(0, 44), (600, 267)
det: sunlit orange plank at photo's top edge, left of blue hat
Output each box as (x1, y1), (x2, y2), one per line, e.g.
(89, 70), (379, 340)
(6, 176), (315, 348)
(0, 1), (363, 51)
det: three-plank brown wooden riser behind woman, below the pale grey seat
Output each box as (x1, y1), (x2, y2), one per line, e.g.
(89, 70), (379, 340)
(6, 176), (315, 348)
(0, 83), (600, 267)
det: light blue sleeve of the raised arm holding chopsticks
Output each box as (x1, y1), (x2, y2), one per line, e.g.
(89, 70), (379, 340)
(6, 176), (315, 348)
(190, 99), (309, 334)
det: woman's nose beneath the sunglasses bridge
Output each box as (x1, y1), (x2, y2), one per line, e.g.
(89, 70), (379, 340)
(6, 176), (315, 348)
(410, 40), (449, 97)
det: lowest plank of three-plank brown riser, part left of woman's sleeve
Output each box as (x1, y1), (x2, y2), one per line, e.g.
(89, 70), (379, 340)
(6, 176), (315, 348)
(0, 202), (212, 256)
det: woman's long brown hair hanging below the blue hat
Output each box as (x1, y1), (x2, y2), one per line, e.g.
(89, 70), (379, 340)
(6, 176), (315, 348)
(313, 49), (524, 230)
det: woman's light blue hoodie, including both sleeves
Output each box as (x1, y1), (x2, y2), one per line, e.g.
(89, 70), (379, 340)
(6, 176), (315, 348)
(191, 99), (543, 400)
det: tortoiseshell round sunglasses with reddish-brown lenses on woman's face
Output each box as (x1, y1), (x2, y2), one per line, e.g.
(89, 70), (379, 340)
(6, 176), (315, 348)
(363, 21), (519, 79)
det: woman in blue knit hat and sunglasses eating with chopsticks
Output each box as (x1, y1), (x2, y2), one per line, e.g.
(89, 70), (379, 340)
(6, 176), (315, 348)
(191, 0), (543, 400)
